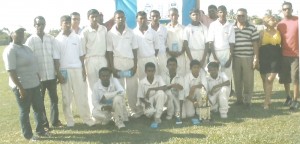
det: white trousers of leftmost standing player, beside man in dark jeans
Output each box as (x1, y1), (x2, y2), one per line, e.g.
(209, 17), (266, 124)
(61, 68), (94, 126)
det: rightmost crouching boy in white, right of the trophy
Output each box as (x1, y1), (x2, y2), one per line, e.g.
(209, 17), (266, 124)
(206, 62), (230, 118)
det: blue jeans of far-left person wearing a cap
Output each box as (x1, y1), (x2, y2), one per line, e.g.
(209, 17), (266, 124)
(12, 86), (45, 139)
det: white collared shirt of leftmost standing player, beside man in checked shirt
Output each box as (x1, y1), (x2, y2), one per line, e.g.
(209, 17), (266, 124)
(53, 32), (84, 69)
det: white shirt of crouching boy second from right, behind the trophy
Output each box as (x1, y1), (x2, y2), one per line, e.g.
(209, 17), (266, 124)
(184, 72), (206, 97)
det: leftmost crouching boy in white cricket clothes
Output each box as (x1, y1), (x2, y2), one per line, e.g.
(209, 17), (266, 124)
(92, 67), (128, 129)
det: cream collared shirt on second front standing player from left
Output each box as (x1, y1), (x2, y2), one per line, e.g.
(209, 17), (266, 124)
(81, 24), (107, 58)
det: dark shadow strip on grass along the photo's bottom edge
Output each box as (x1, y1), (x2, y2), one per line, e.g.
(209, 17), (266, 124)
(43, 126), (206, 143)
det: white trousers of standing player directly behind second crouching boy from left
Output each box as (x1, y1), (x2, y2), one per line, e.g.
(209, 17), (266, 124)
(137, 56), (158, 80)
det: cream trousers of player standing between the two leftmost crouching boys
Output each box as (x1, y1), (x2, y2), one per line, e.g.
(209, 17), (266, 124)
(114, 57), (143, 114)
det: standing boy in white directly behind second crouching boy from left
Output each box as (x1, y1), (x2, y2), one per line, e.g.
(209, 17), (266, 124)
(133, 11), (159, 80)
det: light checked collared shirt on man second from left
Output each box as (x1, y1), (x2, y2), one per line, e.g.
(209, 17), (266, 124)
(25, 34), (57, 81)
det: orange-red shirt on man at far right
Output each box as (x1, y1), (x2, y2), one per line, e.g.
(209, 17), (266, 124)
(277, 16), (299, 57)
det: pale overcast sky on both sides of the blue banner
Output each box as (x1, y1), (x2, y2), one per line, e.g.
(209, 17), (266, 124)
(0, 0), (300, 32)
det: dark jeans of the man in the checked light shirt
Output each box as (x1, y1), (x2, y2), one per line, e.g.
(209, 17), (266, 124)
(41, 79), (60, 128)
